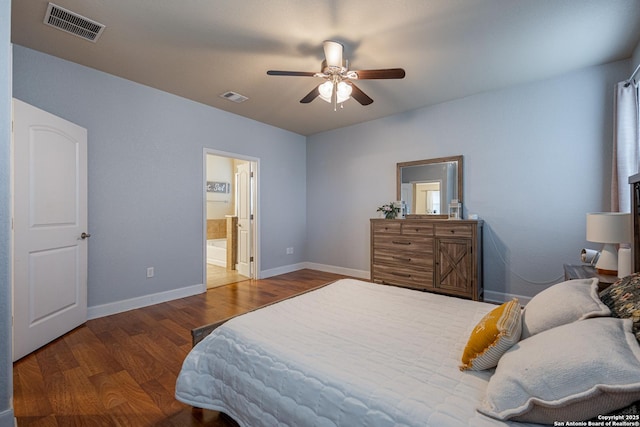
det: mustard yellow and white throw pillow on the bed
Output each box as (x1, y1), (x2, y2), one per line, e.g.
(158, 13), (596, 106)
(460, 298), (522, 371)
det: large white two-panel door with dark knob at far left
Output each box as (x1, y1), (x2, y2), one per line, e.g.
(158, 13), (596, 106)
(13, 99), (88, 360)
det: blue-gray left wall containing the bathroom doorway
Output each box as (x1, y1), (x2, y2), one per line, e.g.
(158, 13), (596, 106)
(13, 46), (306, 307)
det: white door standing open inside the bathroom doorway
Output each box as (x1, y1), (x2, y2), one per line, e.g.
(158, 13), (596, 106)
(236, 162), (253, 277)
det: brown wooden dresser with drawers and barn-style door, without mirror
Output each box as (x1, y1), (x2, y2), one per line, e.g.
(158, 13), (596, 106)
(371, 219), (483, 301)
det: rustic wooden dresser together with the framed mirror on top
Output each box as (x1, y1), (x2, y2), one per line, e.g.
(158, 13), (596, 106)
(370, 156), (484, 301)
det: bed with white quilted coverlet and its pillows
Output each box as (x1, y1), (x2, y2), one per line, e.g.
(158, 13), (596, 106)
(176, 279), (640, 427)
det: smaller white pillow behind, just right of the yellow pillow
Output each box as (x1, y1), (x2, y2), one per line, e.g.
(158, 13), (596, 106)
(520, 278), (611, 339)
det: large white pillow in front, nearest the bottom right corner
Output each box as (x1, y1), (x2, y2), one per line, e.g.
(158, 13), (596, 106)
(478, 317), (640, 424)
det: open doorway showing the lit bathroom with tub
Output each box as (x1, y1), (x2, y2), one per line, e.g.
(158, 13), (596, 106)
(203, 149), (259, 289)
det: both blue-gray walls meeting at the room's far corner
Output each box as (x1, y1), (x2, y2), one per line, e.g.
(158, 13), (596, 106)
(6, 46), (631, 306)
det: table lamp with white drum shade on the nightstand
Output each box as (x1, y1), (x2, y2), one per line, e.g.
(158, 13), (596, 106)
(587, 212), (631, 275)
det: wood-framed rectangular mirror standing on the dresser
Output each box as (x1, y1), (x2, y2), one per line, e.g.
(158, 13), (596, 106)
(397, 156), (462, 217)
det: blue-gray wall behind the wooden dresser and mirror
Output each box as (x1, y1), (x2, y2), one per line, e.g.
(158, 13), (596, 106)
(307, 61), (630, 298)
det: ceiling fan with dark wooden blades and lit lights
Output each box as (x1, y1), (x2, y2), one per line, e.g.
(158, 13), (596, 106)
(267, 40), (405, 111)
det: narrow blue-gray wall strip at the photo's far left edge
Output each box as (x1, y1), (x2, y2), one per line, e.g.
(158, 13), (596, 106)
(0, 0), (14, 427)
